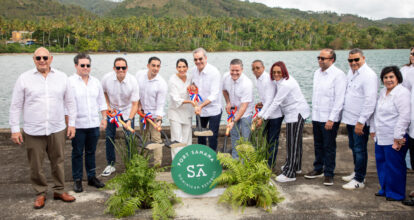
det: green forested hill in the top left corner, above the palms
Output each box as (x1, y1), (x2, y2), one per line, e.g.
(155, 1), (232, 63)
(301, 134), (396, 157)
(0, 0), (93, 20)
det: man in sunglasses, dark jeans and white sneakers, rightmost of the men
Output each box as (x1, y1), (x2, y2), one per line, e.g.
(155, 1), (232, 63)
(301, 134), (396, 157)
(342, 48), (378, 189)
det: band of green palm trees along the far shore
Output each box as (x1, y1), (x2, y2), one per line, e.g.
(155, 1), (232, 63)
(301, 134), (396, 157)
(0, 16), (414, 53)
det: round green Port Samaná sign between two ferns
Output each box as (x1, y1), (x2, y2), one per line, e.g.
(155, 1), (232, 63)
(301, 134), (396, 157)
(171, 144), (222, 195)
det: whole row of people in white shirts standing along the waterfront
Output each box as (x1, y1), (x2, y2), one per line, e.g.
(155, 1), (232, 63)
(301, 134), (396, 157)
(9, 47), (414, 209)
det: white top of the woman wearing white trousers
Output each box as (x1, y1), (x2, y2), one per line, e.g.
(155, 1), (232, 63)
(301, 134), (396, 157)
(168, 74), (194, 125)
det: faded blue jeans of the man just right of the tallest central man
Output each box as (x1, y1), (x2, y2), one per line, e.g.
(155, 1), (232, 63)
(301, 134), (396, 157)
(230, 116), (252, 159)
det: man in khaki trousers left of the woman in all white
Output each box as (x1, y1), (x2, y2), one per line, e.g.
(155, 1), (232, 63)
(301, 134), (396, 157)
(136, 57), (168, 144)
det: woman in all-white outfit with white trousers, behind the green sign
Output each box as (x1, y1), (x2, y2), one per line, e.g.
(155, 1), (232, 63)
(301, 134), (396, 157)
(168, 59), (194, 156)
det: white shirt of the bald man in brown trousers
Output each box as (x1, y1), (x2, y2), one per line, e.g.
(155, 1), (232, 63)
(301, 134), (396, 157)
(9, 68), (76, 136)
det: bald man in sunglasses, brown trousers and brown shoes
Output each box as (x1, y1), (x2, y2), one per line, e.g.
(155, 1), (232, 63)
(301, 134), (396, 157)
(9, 47), (76, 209)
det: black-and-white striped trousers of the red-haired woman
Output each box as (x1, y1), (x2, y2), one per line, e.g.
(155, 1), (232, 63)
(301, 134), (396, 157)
(282, 114), (305, 178)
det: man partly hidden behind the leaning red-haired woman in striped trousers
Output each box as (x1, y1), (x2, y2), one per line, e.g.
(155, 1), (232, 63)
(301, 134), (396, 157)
(252, 60), (283, 168)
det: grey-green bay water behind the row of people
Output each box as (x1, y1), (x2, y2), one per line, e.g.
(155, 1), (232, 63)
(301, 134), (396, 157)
(0, 49), (409, 128)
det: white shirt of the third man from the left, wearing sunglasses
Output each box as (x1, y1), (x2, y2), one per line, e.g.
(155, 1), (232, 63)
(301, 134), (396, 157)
(101, 71), (140, 118)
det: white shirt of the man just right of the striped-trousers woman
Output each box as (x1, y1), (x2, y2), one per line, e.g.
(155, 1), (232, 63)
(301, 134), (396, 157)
(312, 64), (346, 122)
